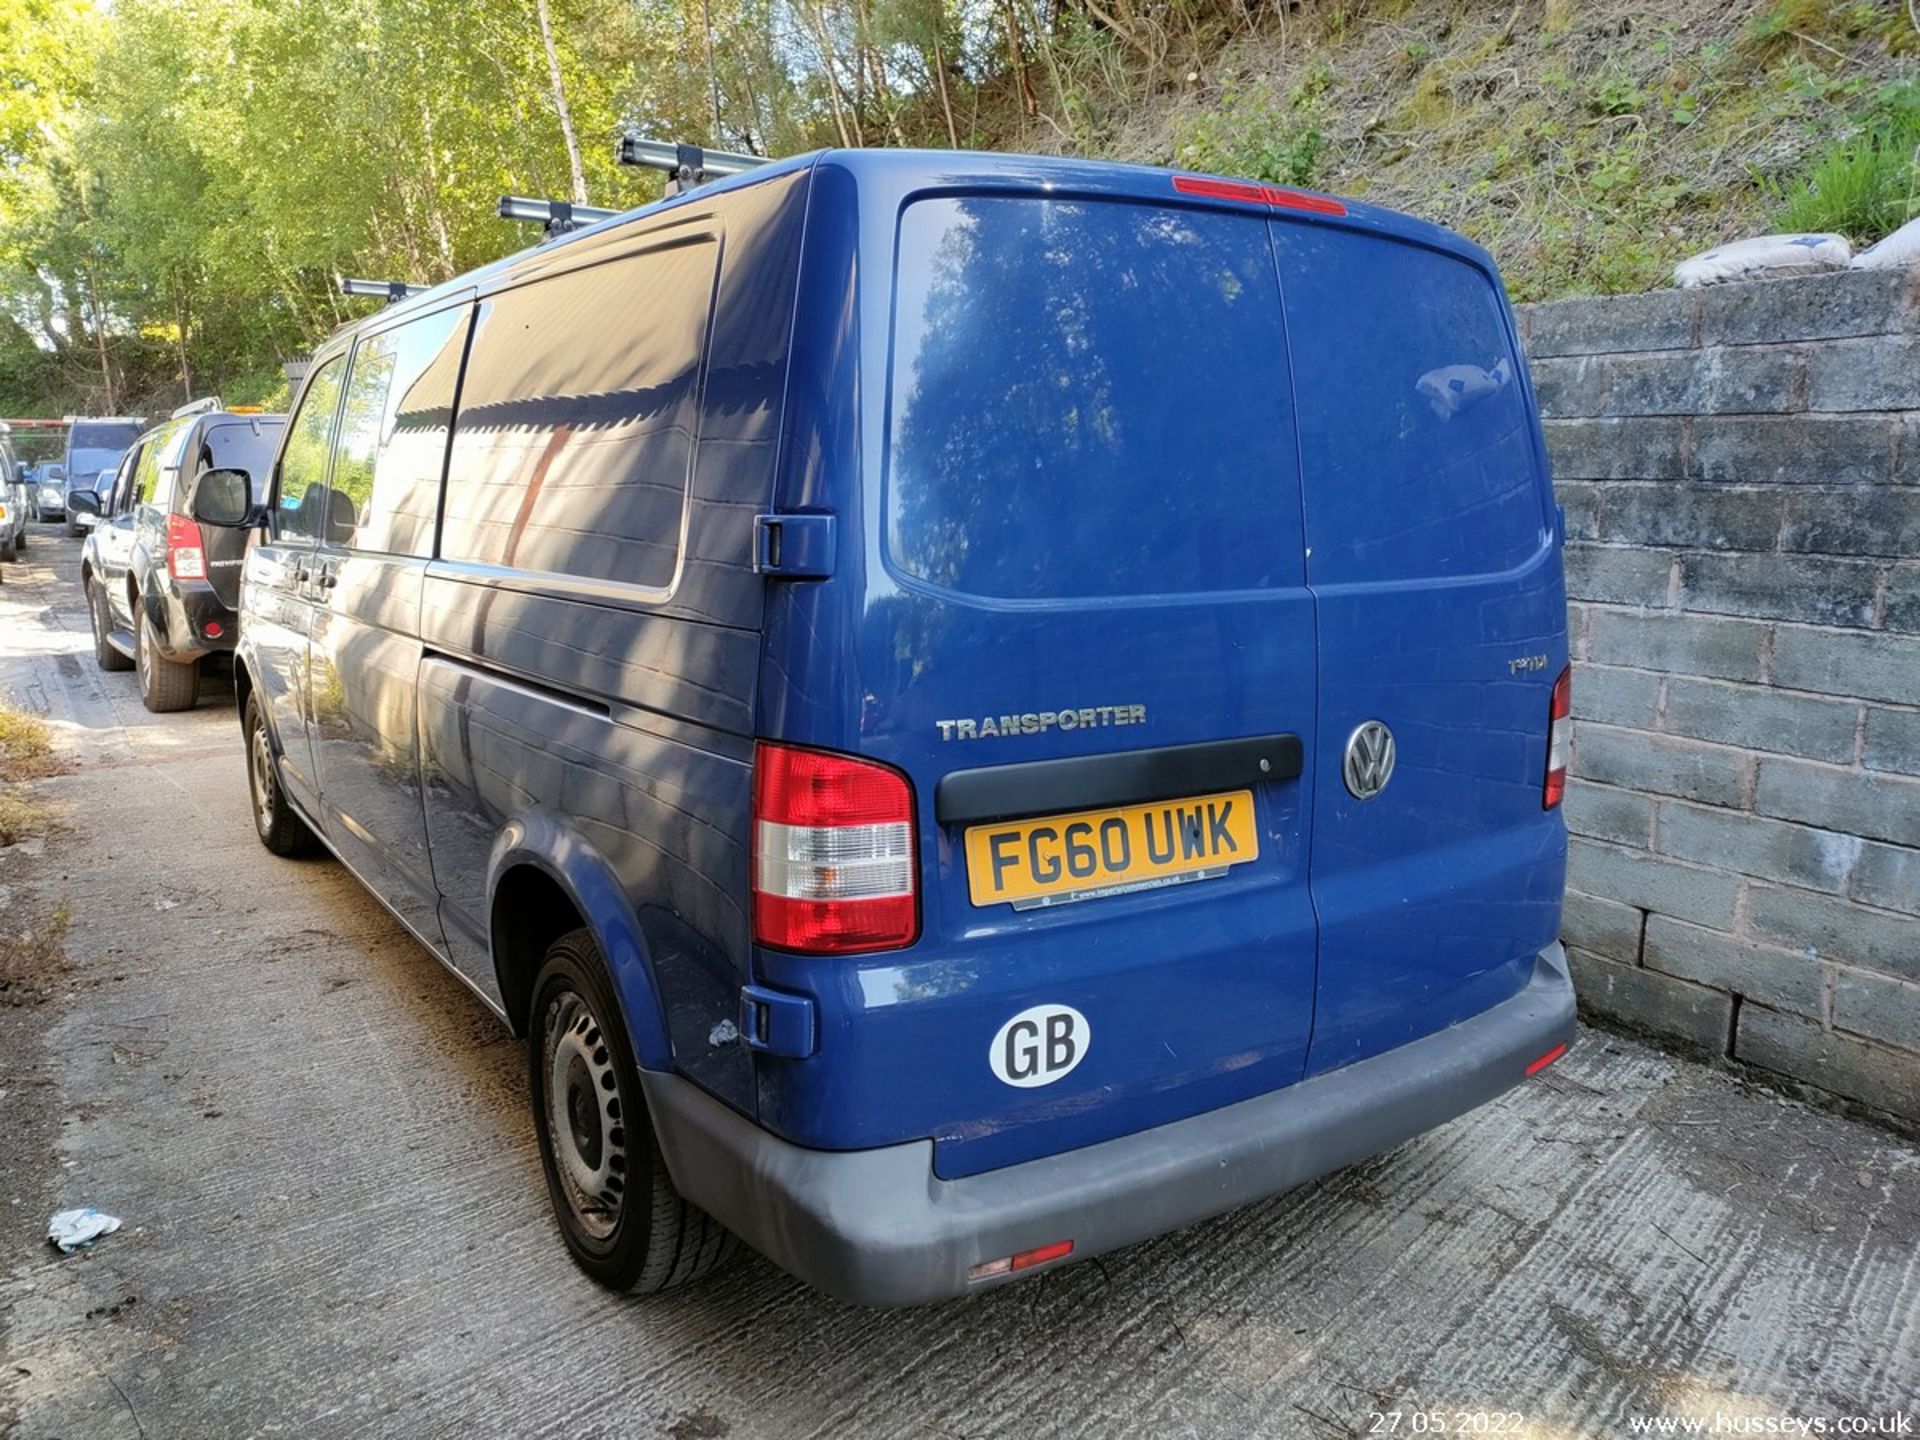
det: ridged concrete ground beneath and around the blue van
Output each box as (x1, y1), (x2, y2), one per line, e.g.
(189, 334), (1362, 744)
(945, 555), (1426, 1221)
(0, 528), (1920, 1440)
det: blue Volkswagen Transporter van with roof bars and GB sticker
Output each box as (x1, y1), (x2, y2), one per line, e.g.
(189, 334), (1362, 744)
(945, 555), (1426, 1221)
(192, 152), (1574, 1304)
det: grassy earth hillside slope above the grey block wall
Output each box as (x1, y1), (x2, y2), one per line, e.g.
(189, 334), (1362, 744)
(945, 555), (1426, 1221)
(1016, 0), (1920, 300)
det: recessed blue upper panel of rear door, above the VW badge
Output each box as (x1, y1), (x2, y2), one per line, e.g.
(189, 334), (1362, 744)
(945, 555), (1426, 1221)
(1279, 225), (1546, 584)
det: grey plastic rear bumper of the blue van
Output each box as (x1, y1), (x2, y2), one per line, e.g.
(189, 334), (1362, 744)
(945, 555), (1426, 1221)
(641, 945), (1574, 1306)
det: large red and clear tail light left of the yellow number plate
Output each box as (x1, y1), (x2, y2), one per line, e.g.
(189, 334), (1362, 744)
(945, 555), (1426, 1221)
(753, 743), (920, 954)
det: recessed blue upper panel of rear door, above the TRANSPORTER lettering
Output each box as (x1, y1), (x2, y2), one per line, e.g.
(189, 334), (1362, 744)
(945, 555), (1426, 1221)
(887, 196), (1300, 599)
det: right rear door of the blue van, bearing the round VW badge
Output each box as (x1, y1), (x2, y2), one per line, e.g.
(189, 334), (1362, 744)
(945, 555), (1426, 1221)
(1273, 221), (1567, 1073)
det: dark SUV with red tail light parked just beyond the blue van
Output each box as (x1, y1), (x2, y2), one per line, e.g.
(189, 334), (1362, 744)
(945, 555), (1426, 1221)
(71, 399), (286, 710)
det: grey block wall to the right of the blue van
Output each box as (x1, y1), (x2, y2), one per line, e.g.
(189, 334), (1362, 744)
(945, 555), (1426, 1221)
(1521, 271), (1920, 1121)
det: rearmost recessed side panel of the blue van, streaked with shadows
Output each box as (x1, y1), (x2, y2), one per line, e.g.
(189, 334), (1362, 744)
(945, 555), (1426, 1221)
(440, 236), (718, 589)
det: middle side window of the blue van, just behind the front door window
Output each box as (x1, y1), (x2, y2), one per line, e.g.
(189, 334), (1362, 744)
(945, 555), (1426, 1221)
(326, 307), (468, 559)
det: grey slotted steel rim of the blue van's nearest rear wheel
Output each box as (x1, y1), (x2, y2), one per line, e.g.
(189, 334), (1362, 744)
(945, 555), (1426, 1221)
(541, 991), (626, 1240)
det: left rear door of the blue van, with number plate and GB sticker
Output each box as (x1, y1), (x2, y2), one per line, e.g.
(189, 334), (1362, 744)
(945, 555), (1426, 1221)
(764, 192), (1315, 1175)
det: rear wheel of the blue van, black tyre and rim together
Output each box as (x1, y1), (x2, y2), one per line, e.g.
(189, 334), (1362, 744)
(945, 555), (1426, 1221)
(526, 929), (735, 1294)
